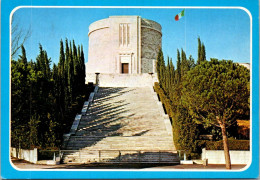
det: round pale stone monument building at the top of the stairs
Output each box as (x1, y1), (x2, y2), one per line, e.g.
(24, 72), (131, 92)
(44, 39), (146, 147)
(86, 16), (162, 86)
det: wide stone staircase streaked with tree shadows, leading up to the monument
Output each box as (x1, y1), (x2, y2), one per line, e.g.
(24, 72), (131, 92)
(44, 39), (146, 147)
(63, 87), (180, 163)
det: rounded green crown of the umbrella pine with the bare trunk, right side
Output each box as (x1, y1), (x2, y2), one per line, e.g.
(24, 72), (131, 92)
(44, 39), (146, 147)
(182, 59), (250, 127)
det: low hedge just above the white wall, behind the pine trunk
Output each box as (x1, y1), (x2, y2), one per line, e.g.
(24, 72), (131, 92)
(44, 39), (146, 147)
(197, 140), (250, 150)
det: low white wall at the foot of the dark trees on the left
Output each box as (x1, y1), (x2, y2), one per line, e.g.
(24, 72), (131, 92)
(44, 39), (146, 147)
(11, 147), (38, 163)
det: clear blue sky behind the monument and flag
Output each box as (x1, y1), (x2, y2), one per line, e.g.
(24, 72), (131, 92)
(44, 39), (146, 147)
(14, 8), (250, 67)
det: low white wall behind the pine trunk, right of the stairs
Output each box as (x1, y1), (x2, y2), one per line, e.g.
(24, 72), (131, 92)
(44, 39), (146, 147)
(201, 148), (251, 164)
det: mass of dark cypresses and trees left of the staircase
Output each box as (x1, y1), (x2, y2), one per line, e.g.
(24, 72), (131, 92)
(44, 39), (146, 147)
(11, 39), (90, 148)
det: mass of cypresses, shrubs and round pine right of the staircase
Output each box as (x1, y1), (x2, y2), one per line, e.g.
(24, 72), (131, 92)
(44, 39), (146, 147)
(154, 38), (250, 160)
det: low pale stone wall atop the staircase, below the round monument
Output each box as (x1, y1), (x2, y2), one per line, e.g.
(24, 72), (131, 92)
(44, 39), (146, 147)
(86, 73), (158, 87)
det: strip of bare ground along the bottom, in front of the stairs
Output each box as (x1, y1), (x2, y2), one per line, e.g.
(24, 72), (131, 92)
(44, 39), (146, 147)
(12, 158), (246, 170)
